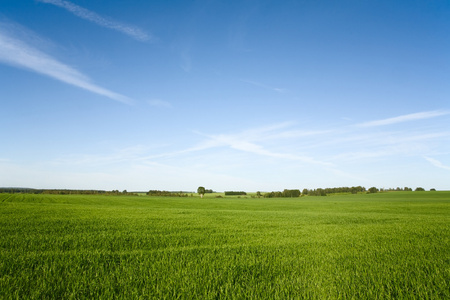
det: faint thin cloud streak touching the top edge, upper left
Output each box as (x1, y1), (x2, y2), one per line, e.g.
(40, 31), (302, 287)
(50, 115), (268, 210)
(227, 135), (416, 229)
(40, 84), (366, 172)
(37, 0), (152, 41)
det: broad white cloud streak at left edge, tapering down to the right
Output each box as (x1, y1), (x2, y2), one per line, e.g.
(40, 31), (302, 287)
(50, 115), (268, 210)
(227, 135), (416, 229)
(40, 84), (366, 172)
(0, 23), (133, 104)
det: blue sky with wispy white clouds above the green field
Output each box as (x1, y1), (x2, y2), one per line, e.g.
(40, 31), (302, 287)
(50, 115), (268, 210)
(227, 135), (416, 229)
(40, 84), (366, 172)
(0, 0), (450, 192)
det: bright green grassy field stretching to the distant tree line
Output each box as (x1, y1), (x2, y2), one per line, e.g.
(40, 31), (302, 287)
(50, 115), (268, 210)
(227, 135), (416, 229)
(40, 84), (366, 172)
(0, 192), (450, 299)
